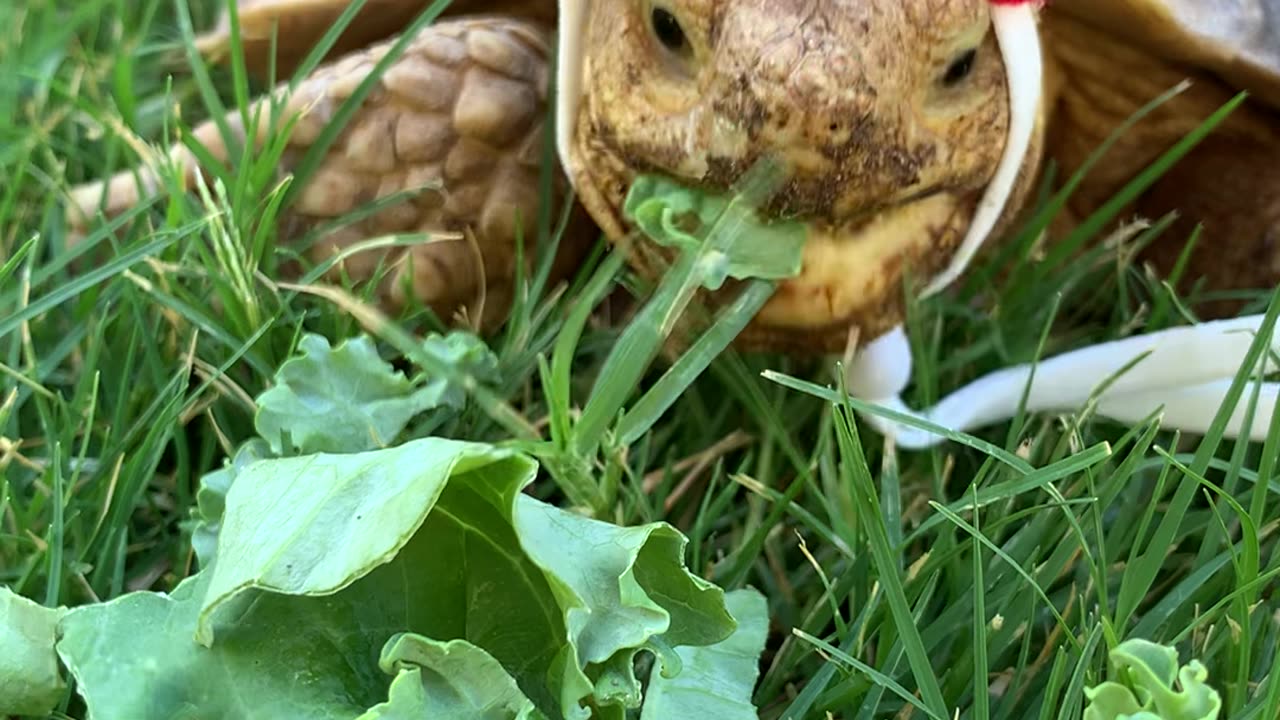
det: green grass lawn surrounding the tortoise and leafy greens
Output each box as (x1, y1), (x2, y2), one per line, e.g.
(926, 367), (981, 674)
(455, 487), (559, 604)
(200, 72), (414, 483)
(0, 0), (1280, 720)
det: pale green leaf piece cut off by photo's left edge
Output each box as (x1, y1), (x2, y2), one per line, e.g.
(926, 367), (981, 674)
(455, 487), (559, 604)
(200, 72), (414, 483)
(0, 587), (67, 716)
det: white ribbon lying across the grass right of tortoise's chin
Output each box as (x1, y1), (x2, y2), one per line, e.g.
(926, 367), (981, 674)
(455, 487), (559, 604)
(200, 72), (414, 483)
(847, 315), (1280, 450)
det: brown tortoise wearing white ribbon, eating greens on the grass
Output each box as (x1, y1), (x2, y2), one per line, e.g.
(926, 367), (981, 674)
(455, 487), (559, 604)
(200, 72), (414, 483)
(68, 0), (1280, 447)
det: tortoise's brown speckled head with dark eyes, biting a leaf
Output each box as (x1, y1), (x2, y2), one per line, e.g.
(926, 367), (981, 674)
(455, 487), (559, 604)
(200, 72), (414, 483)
(559, 0), (1041, 351)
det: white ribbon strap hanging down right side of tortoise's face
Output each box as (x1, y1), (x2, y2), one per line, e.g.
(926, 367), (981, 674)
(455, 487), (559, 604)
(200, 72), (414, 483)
(923, 3), (1044, 297)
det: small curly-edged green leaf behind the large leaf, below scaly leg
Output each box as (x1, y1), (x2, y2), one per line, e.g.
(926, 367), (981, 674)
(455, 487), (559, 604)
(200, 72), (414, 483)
(256, 332), (497, 455)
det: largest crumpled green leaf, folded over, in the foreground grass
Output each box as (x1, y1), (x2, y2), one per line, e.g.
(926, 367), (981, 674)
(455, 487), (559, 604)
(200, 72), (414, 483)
(45, 438), (752, 720)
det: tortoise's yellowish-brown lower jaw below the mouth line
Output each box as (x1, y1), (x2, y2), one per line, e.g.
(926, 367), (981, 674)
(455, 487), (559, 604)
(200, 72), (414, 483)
(570, 112), (1039, 354)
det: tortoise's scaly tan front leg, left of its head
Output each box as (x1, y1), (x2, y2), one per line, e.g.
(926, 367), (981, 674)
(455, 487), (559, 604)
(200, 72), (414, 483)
(68, 18), (581, 327)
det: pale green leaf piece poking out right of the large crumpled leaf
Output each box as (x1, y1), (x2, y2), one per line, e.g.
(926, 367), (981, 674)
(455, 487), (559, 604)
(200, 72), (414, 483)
(640, 589), (769, 720)
